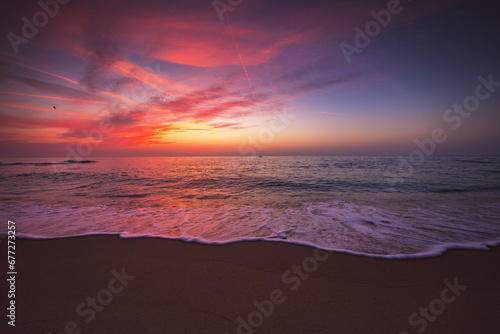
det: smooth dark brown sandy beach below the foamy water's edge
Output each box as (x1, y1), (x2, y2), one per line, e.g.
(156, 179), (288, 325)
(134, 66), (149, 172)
(2, 236), (500, 334)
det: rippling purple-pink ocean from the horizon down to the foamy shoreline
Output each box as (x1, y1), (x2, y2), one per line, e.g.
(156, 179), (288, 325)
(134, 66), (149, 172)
(0, 156), (500, 258)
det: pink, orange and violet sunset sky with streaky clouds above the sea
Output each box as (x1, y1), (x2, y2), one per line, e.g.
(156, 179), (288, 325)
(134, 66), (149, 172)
(0, 0), (500, 159)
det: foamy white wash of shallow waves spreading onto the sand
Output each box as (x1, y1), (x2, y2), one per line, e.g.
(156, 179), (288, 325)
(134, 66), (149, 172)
(0, 201), (500, 258)
